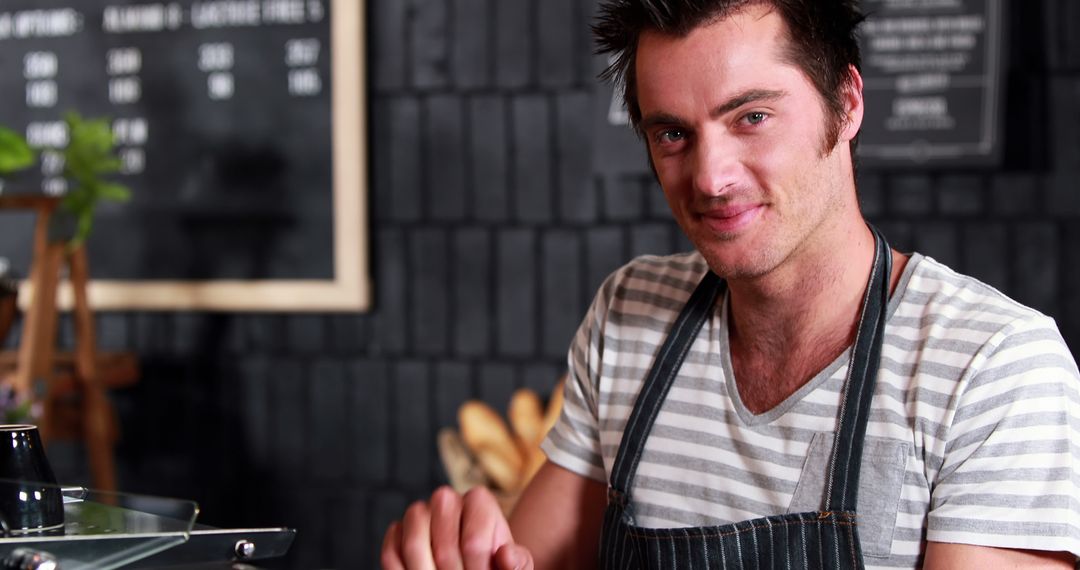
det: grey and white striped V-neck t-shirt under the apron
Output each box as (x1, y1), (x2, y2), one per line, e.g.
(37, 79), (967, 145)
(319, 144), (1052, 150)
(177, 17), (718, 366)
(544, 253), (1080, 568)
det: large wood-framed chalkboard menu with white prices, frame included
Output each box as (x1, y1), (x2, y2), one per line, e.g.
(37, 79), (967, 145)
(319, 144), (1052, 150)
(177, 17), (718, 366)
(0, 0), (369, 311)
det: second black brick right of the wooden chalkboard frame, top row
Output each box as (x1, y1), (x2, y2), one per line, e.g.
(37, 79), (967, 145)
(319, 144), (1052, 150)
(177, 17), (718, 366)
(409, 0), (450, 90)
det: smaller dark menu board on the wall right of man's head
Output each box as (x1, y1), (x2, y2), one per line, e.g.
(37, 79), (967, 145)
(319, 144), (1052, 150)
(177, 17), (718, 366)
(859, 0), (1004, 168)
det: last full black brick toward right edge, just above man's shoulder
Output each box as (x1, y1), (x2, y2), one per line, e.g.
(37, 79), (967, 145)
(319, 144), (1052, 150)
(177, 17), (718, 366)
(1012, 222), (1059, 314)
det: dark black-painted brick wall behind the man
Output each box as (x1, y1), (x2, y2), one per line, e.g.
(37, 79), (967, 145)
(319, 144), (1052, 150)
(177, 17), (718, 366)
(4, 0), (1080, 569)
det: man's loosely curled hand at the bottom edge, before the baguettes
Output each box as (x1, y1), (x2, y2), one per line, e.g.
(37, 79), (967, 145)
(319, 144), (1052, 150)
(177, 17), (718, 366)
(382, 487), (532, 570)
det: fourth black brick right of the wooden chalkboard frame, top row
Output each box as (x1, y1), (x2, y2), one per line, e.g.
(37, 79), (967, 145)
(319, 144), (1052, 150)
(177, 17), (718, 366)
(495, 0), (532, 89)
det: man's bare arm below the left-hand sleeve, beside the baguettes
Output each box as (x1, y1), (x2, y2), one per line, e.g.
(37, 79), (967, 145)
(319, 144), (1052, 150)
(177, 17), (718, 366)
(510, 462), (607, 570)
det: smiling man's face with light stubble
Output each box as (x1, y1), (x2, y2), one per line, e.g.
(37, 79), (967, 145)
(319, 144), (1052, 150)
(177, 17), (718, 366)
(636, 6), (858, 279)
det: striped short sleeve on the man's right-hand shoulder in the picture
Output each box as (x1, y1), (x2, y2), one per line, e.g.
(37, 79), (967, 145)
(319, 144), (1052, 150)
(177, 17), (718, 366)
(927, 315), (1080, 556)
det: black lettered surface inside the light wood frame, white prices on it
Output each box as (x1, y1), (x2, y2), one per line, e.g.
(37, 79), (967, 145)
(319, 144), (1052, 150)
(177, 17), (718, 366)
(0, 0), (333, 279)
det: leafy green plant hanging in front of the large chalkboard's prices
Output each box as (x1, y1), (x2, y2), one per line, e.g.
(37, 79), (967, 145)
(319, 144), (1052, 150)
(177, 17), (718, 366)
(60, 111), (131, 249)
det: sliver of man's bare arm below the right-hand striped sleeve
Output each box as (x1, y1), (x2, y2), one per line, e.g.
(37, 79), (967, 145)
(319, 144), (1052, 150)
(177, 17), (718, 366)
(923, 541), (1076, 570)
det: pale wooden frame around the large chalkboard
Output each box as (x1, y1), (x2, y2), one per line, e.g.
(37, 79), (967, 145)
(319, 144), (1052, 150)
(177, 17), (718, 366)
(33, 0), (372, 312)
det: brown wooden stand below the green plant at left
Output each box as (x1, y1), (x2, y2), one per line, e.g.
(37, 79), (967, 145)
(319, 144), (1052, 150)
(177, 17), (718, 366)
(0, 195), (138, 491)
